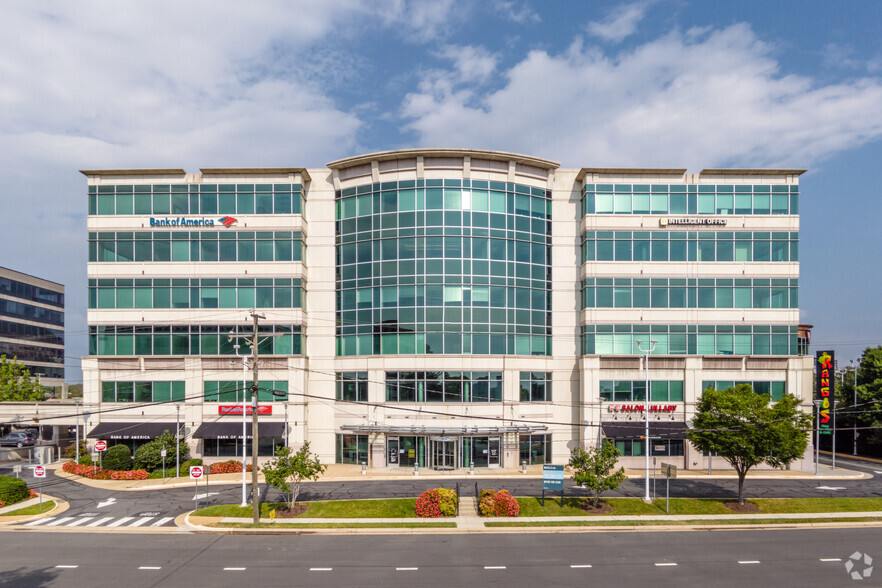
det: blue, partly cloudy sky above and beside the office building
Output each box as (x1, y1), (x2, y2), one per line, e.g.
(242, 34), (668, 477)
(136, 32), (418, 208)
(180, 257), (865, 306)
(0, 0), (882, 382)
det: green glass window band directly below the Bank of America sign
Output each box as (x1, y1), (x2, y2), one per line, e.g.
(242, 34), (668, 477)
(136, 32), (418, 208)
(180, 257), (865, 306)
(89, 230), (303, 262)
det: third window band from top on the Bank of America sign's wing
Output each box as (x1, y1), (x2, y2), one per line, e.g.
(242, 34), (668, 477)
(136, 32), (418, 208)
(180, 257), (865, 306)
(88, 278), (306, 309)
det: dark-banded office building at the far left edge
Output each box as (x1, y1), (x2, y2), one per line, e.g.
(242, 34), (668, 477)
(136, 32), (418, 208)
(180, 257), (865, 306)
(0, 267), (64, 389)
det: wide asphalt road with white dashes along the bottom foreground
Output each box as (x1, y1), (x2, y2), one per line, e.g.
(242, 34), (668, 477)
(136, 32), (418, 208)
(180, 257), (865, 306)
(0, 527), (882, 588)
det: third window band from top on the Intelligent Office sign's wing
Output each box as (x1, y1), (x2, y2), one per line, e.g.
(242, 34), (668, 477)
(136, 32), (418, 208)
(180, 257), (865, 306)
(582, 278), (799, 308)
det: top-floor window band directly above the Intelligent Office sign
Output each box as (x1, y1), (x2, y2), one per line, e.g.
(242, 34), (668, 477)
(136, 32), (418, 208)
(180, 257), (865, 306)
(582, 184), (799, 216)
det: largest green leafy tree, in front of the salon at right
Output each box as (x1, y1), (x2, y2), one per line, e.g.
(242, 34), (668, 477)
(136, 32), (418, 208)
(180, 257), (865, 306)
(687, 384), (812, 504)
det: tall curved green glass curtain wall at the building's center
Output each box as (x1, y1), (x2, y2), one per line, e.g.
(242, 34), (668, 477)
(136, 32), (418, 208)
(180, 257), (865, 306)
(336, 179), (551, 356)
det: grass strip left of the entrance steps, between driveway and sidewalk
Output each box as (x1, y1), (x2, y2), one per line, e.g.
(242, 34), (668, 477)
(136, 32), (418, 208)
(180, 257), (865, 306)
(193, 498), (417, 524)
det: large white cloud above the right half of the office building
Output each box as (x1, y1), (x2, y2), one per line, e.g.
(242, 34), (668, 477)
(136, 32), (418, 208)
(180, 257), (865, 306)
(403, 24), (882, 169)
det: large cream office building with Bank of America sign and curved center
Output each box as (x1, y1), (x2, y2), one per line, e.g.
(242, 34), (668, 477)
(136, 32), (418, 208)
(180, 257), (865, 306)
(83, 149), (811, 469)
